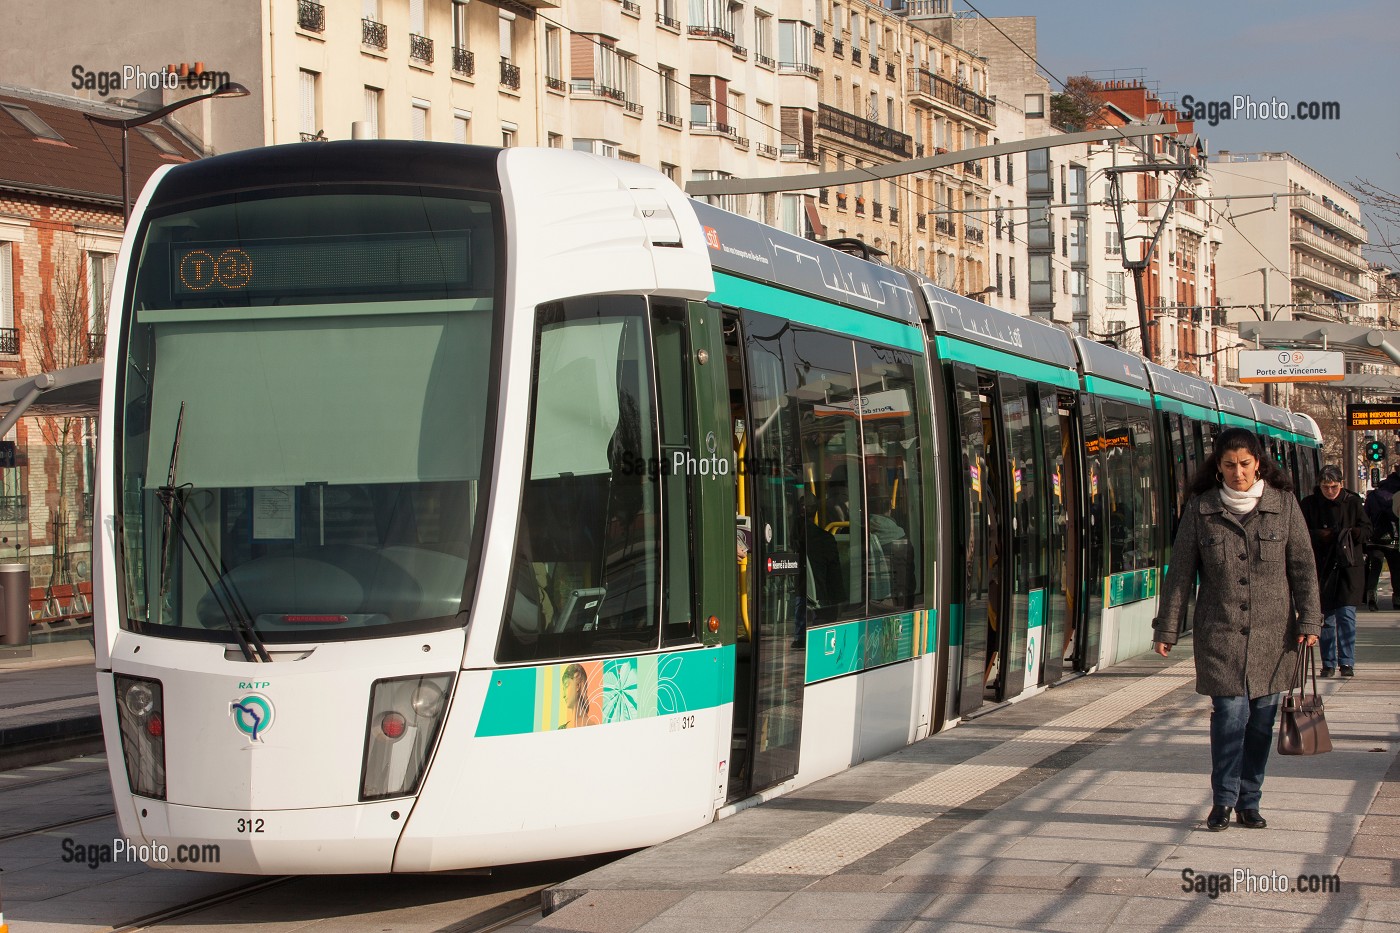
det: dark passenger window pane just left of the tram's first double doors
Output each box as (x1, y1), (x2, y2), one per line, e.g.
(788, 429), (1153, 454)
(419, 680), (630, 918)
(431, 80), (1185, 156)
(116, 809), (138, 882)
(855, 337), (927, 615)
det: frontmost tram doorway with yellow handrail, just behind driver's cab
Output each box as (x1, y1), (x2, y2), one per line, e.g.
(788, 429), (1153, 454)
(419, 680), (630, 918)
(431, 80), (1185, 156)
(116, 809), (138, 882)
(724, 315), (806, 800)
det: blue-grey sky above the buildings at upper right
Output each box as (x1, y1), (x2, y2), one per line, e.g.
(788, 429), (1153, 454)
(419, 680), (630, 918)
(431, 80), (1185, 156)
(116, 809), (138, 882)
(955, 0), (1400, 257)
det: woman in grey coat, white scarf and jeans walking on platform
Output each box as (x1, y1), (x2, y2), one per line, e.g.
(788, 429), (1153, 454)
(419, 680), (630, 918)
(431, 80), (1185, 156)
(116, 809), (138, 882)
(1152, 427), (1322, 832)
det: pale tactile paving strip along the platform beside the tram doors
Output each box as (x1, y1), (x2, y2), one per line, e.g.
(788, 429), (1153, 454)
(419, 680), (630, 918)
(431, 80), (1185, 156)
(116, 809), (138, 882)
(729, 661), (1196, 876)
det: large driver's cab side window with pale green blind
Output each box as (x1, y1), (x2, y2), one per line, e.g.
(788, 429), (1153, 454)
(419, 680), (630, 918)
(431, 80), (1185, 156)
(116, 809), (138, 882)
(497, 296), (661, 661)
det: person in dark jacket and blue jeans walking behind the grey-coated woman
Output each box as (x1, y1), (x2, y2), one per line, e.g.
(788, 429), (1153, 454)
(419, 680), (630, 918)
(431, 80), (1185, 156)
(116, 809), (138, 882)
(1302, 464), (1371, 677)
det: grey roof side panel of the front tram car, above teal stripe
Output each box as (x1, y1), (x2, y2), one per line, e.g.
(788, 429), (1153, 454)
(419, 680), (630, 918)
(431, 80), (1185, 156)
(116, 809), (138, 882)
(690, 200), (918, 326)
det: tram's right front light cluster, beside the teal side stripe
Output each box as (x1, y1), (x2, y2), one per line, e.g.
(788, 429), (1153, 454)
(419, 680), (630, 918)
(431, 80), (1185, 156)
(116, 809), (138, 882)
(360, 674), (452, 800)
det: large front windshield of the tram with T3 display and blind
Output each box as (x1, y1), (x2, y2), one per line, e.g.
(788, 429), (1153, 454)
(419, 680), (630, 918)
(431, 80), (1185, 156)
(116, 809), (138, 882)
(118, 185), (497, 642)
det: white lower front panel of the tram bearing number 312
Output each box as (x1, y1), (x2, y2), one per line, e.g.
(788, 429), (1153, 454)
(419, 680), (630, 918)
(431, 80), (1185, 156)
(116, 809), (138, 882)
(123, 797), (413, 874)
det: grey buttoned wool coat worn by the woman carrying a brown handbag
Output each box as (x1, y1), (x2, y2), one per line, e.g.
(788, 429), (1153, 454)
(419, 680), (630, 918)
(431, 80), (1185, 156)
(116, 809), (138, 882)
(1152, 486), (1322, 699)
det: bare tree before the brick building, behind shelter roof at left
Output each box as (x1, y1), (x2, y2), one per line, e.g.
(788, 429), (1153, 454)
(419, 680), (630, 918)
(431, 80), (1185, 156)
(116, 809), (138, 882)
(25, 248), (108, 583)
